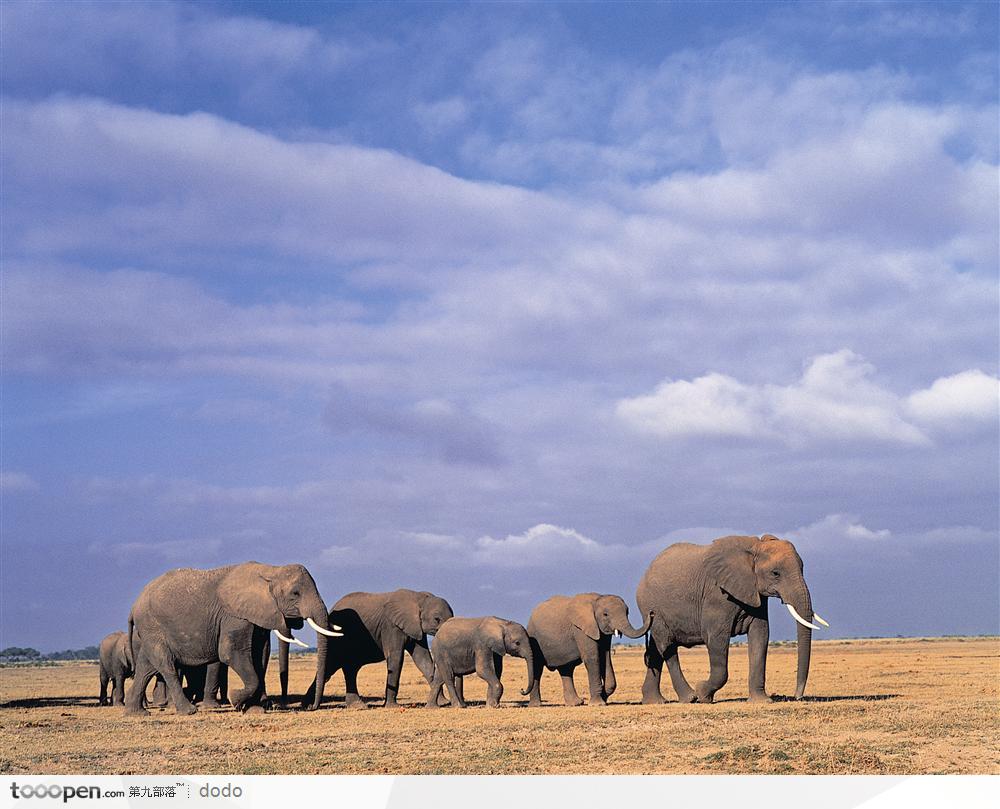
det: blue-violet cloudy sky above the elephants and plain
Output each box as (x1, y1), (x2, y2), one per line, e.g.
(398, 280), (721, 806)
(0, 2), (1000, 650)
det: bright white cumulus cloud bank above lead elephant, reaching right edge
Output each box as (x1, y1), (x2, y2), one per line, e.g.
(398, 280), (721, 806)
(616, 349), (998, 446)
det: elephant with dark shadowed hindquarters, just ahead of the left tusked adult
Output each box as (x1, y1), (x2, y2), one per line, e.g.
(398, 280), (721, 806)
(294, 589), (454, 708)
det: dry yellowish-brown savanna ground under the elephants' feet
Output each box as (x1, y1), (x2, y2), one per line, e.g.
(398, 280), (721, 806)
(0, 638), (1000, 774)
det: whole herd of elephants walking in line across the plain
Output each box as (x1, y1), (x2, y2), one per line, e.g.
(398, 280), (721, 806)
(100, 534), (829, 715)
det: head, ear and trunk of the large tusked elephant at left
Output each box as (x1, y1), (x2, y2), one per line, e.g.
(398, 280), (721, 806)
(219, 562), (342, 708)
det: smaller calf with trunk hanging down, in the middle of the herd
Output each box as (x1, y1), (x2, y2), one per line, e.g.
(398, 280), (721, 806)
(427, 616), (534, 708)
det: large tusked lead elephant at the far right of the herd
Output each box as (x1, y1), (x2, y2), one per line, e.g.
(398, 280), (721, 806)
(636, 534), (813, 704)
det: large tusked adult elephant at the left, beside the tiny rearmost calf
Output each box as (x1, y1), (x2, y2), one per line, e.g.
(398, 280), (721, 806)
(125, 562), (329, 714)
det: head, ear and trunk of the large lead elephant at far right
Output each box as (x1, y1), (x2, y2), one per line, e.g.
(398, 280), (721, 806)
(707, 534), (826, 699)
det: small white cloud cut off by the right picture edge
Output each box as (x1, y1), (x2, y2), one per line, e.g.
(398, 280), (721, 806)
(906, 368), (1000, 429)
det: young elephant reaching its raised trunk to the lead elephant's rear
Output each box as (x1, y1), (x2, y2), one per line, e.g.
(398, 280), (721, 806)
(528, 593), (649, 707)
